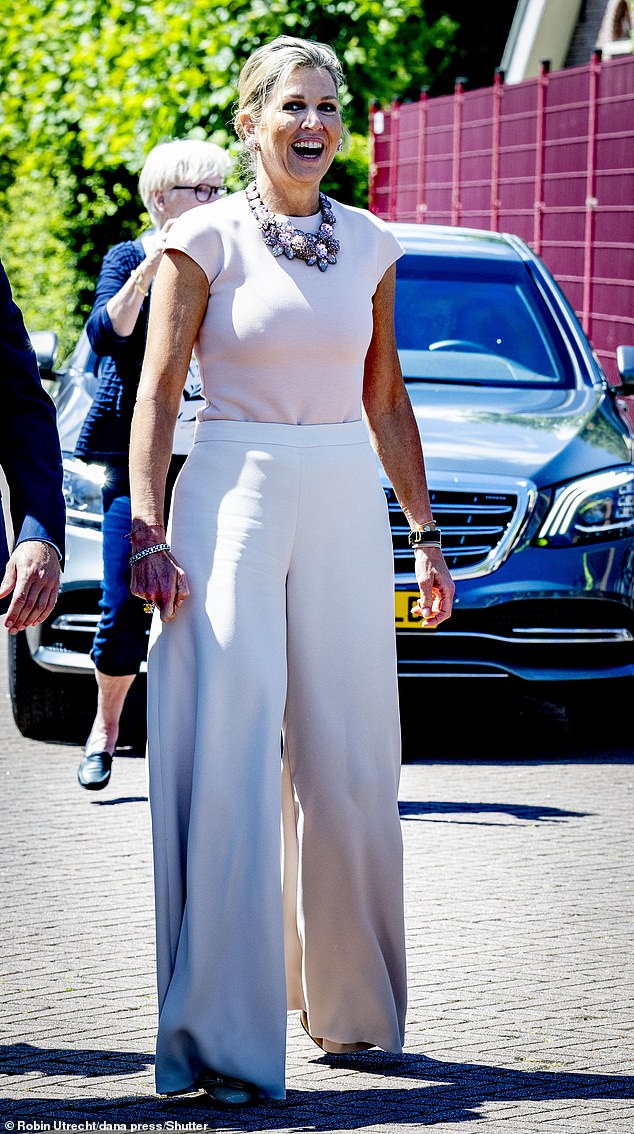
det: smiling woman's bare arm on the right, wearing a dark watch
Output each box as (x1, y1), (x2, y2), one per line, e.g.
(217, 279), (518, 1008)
(363, 265), (454, 626)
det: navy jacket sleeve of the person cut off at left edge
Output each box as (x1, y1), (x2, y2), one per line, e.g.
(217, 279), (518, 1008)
(0, 263), (66, 613)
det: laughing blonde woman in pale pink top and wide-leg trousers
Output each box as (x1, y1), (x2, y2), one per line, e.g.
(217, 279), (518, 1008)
(132, 36), (453, 1107)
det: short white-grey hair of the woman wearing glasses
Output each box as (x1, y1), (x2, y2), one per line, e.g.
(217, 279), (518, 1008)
(138, 138), (230, 225)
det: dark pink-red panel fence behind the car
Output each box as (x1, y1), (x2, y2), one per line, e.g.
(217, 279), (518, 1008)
(370, 54), (634, 380)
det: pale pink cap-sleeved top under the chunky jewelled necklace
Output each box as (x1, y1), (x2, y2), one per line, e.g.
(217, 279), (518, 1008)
(162, 192), (403, 425)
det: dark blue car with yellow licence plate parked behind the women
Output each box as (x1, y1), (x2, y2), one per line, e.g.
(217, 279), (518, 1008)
(10, 225), (634, 742)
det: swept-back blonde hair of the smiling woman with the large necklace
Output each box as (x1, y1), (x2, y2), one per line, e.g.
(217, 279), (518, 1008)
(234, 35), (344, 174)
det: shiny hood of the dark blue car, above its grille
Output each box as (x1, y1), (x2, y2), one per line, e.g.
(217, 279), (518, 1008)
(407, 382), (632, 488)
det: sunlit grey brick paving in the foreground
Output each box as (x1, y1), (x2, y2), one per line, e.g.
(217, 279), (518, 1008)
(0, 633), (634, 1134)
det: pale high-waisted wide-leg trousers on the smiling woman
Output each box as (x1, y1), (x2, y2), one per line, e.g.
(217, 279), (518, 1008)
(147, 421), (406, 1099)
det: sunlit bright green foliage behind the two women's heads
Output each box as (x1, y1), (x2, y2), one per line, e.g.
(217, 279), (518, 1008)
(0, 0), (457, 344)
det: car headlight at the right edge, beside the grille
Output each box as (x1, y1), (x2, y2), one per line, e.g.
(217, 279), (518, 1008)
(536, 468), (634, 548)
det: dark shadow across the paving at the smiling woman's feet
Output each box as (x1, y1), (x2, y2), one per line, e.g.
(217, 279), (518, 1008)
(0, 1044), (634, 1131)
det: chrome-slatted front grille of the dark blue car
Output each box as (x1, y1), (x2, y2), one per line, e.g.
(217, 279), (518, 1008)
(384, 485), (526, 577)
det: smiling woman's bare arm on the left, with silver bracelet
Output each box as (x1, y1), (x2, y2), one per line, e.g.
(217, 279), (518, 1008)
(130, 251), (209, 620)
